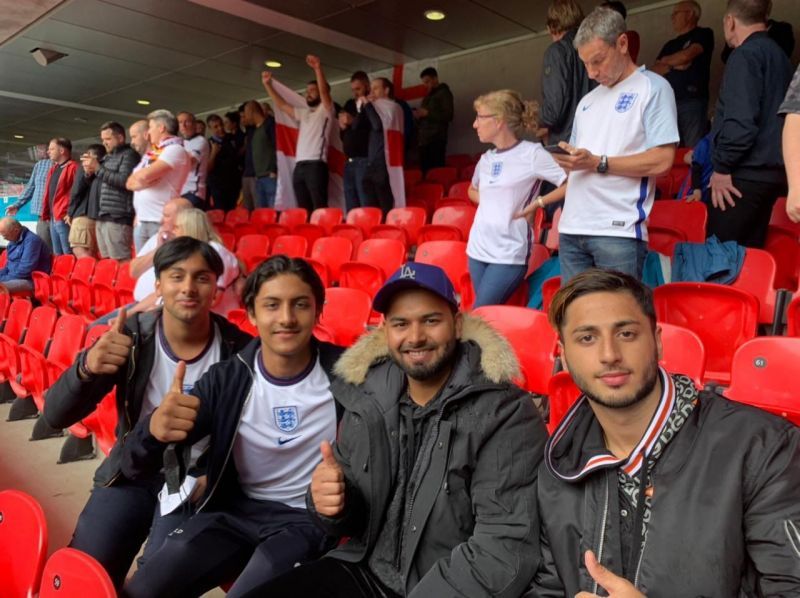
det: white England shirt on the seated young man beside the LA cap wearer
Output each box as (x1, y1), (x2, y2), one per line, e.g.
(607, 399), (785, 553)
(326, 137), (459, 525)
(233, 351), (336, 509)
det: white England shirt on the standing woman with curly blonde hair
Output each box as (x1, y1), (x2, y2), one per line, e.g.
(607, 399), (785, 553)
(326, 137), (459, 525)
(467, 141), (567, 265)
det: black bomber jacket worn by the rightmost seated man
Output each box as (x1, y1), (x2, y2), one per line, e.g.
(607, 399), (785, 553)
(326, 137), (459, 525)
(528, 376), (800, 598)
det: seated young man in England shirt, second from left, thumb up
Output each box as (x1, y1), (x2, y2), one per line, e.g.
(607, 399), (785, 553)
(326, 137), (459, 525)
(123, 255), (341, 598)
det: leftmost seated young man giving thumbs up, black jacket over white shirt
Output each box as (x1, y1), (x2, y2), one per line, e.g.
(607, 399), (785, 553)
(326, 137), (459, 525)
(44, 237), (251, 587)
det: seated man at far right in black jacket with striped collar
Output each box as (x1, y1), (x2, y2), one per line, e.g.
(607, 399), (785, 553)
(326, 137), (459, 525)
(528, 270), (800, 598)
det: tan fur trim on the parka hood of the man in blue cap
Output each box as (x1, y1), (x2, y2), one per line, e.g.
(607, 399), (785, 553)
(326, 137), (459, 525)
(334, 314), (520, 386)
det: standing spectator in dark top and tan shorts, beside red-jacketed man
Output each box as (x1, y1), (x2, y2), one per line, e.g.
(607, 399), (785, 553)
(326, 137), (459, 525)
(67, 143), (106, 258)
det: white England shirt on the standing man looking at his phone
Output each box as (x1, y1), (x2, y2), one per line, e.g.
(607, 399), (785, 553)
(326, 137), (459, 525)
(558, 67), (680, 241)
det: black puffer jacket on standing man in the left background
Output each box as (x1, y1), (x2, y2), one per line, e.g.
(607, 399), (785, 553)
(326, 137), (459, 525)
(97, 143), (139, 224)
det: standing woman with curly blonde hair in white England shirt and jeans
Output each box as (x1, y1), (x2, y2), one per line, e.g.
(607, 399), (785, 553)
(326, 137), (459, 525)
(467, 89), (567, 307)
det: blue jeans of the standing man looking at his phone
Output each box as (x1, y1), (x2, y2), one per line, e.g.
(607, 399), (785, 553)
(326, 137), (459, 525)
(558, 234), (647, 286)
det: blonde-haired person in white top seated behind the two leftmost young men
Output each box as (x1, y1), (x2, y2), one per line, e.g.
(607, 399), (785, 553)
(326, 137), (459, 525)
(173, 208), (245, 317)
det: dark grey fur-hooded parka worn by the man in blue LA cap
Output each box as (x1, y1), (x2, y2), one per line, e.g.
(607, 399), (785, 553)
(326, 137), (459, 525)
(307, 317), (546, 598)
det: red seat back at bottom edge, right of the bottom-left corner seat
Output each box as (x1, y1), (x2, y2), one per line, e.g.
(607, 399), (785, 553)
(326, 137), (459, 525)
(39, 548), (117, 598)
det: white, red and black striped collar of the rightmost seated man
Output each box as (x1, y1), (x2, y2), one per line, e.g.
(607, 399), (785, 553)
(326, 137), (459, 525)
(545, 368), (675, 481)
